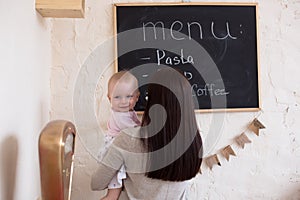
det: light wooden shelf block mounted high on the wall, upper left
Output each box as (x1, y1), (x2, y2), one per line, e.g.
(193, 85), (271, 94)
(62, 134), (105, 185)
(35, 0), (85, 18)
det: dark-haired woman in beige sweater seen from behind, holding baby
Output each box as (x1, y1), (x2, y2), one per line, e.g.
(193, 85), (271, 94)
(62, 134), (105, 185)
(91, 68), (202, 200)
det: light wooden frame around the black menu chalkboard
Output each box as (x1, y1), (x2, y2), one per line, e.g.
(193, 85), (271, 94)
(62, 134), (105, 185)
(113, 2), (261, 113)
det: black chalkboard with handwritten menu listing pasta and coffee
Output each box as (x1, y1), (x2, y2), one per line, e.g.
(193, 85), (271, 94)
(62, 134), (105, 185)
(114, 3), (260, 111)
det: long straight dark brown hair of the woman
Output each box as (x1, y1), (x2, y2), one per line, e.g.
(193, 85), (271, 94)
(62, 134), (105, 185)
(141, 68), (202, 181)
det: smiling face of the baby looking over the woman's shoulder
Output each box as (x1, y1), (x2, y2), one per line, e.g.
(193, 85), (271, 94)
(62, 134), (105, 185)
(108, 82), (139, 112)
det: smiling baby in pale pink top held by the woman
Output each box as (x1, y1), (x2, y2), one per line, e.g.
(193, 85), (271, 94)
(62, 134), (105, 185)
(99, 71), (140, 200)
